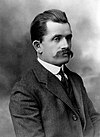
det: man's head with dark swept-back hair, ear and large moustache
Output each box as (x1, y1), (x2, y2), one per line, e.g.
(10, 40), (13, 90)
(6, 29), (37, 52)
(30, 9), (72, 66)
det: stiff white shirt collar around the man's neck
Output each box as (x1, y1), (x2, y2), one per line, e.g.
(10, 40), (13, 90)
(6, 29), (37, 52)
(37, 58), (61, 75)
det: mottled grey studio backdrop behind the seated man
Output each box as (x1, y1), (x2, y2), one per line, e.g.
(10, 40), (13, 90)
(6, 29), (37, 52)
(0, 0), (100, 137)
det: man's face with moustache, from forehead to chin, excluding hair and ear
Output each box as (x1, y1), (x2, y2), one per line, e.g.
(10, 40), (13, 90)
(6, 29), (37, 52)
(40, 21), (72, 66)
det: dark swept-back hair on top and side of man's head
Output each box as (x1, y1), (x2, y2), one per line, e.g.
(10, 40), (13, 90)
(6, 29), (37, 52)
(30, 9), (70, 42)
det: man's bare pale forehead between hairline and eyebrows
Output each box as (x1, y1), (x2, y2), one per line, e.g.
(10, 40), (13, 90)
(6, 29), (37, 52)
(46, 21), (72, 35)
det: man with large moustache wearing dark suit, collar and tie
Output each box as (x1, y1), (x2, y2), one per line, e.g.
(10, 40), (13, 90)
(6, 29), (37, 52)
(10, 9), (100, 137)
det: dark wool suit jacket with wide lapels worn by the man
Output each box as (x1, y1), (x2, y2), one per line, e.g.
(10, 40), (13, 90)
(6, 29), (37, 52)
(9, 61), (100, 137)
